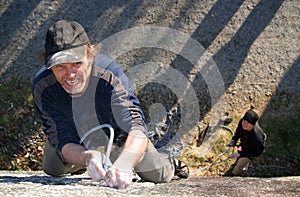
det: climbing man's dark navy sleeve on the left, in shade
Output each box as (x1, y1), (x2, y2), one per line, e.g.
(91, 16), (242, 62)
(32, 70), (80, 157)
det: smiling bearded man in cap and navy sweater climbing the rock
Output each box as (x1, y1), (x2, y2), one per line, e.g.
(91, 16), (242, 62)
(32, 20), (188, 188)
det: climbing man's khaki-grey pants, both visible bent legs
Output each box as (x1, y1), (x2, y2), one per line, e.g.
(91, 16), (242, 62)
(43, 140), (175, 183)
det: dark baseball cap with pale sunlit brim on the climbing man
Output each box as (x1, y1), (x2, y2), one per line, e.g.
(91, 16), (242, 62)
(45, 20), (90, 69)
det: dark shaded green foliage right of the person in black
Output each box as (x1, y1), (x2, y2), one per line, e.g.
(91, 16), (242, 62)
(261, 106), (300, 176)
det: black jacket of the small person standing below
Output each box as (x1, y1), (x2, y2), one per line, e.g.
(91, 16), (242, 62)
(232, 120), (265, 159)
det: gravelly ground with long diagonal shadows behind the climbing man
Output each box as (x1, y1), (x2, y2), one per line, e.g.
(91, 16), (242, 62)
(0, 0), (300, 174)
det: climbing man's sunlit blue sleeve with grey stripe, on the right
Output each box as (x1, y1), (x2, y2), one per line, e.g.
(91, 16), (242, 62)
(94, 55), (146, 133)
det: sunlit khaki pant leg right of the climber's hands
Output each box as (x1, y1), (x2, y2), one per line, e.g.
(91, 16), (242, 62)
(134, 141), (175, 183)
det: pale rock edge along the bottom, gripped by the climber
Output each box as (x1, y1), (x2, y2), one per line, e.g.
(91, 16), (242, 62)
(0, 171), (300, 197)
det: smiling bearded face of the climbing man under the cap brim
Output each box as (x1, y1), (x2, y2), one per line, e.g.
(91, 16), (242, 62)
(51, 54), (92, 97)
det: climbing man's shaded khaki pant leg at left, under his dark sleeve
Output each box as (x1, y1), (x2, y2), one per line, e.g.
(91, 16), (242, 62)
(42, 140), (86, 176)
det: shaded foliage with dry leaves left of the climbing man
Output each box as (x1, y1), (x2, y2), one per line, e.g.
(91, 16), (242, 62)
(0, 78), (44, 170)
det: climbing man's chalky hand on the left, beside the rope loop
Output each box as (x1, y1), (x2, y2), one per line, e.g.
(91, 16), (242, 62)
(87, 150), (106, 181)
